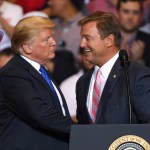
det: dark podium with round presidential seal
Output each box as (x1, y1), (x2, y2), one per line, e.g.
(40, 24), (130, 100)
(69, 124), (150, 150)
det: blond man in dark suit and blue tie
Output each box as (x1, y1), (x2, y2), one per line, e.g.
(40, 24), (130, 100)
(0, 17), (72, 150)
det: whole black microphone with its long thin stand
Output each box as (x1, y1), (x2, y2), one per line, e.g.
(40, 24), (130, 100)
(119, 49), (132, 124)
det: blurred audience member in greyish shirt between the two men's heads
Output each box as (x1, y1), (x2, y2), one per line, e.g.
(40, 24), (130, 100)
(49, 0), (84, 57)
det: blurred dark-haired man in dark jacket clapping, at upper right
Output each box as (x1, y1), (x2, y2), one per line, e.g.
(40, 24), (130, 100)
(117, 0), (150, 67)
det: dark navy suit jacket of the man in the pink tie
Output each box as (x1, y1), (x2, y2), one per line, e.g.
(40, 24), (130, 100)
(76, 56), (150, 124)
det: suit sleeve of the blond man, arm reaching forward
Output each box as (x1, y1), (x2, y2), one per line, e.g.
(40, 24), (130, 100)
(1, 76), (71, 133)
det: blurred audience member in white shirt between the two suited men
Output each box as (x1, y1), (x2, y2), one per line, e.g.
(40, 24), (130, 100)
(60, 48), (93, 121)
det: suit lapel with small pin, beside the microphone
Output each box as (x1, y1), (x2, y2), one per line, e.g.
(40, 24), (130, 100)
(95, 59), (122, 123)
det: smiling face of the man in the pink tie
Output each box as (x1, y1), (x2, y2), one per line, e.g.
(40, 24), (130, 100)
(80, 21), (107, 64)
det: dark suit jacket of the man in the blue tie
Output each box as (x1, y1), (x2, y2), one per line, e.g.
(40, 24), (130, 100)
(0, 56), (71, 150)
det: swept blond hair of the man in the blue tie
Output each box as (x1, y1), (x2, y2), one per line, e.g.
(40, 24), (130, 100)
(11, 16), (55, 54)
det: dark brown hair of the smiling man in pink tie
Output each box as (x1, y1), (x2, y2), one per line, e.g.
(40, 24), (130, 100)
(78, 11), (121, 48)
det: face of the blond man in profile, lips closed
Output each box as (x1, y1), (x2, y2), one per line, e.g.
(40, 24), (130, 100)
(23, 28), (56, 64)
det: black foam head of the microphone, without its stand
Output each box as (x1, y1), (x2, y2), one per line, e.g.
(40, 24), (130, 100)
(119, 49), (130, 68)
